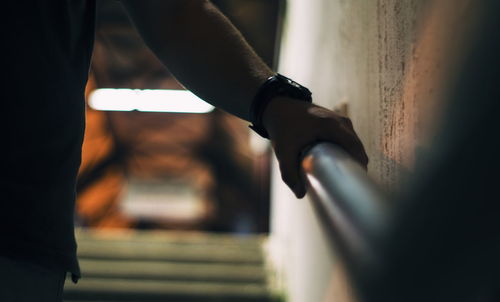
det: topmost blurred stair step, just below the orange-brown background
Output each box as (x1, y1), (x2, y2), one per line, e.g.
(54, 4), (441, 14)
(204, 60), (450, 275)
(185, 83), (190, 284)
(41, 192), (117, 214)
(76, 230), (264, 264)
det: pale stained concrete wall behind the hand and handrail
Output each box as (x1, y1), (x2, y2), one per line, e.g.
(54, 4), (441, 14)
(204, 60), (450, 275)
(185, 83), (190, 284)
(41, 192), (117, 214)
(270, 0), (470, 302)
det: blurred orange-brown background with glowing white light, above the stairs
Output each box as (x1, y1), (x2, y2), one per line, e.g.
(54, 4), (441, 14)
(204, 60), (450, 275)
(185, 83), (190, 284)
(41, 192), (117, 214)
(77, 0), (283, 234)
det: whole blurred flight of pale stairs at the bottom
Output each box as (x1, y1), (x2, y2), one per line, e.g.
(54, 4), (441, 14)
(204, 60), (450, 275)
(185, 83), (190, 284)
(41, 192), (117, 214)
(64, 231), (276, 302)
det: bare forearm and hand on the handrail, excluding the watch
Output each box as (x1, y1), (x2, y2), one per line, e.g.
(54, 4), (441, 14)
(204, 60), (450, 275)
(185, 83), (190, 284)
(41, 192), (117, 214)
(122, 0), (368, 198)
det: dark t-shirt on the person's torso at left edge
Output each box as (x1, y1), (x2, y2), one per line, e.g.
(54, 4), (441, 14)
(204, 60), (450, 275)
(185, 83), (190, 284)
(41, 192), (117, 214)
(0, 0), (95, 275)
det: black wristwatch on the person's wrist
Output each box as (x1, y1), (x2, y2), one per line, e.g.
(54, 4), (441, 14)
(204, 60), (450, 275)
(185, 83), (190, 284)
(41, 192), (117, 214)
(249, 73), (312, 138)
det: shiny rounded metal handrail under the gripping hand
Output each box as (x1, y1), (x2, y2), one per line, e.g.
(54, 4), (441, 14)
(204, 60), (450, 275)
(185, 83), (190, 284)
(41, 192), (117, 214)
(302, 143), (389, 266)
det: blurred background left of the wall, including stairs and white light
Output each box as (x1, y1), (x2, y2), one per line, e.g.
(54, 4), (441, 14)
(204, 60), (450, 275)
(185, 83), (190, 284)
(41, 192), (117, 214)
(64, 0), (284, 302)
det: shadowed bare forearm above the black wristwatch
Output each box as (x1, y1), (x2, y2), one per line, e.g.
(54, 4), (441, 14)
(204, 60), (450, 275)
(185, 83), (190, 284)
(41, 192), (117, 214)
(122, 0), (273, 120)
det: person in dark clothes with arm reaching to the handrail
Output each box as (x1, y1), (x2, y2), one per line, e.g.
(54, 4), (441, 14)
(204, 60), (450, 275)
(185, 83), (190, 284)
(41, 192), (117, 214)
(0, 0), (368, 302)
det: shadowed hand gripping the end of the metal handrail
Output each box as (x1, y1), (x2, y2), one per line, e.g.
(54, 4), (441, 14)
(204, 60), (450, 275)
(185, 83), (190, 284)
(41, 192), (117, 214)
(262, 97), (368, 198)
